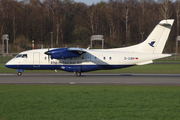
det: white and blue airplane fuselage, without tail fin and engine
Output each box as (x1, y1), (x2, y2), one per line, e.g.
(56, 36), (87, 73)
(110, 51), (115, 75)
(6, 49), (170, 71)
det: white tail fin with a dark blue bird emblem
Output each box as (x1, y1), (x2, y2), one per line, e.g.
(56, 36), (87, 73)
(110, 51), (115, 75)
(116, 19), (174, 53)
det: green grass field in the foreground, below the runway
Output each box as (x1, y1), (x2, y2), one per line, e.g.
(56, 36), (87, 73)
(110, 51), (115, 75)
(0, 85), (180, 120)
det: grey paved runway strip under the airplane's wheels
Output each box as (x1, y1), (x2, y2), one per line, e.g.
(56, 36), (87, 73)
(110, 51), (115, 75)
(0, 73), (180, 86)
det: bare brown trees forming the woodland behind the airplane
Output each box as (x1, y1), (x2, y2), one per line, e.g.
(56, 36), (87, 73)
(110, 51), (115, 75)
(0, 0), (180, 52)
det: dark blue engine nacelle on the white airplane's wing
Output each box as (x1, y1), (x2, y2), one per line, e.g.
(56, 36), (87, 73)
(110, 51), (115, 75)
(45, 48), (79, 59)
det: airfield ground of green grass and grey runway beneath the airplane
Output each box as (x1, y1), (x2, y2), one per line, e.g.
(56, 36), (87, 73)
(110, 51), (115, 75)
(0, 55), (180, 120)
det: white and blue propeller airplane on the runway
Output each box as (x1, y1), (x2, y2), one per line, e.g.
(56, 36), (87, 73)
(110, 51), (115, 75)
(5, 19), (174, 76)
